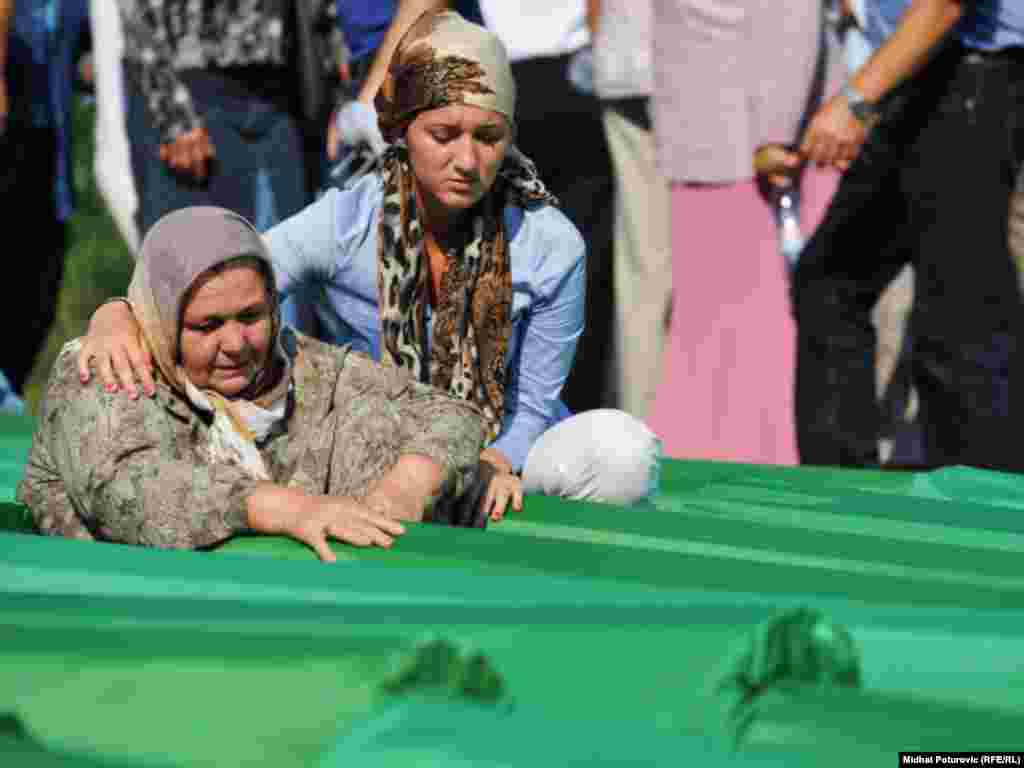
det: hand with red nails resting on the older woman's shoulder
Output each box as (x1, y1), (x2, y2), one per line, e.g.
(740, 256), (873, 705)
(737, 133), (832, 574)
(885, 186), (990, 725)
(78, 301), (157, 399)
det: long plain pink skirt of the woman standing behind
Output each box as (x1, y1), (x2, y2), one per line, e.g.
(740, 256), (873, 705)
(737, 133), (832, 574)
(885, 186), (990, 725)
(647, 170), (838, 465)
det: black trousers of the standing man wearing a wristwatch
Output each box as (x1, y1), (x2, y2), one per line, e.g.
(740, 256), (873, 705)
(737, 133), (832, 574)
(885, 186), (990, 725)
(793, 45), (1024, 469)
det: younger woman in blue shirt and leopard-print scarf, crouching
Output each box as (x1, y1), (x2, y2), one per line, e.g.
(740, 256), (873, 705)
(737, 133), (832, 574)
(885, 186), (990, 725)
(80, 12), (657, 519)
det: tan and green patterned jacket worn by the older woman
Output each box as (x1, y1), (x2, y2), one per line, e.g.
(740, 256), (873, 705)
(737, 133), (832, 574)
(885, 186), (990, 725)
(17, 331), (483, 548)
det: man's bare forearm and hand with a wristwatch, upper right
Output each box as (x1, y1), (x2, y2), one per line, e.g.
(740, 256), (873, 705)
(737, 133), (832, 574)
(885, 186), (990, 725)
(800, 0), (969, 169)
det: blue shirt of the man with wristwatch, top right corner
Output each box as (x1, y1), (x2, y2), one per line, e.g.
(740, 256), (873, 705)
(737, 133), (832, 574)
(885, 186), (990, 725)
(865, 0), (1024, 50)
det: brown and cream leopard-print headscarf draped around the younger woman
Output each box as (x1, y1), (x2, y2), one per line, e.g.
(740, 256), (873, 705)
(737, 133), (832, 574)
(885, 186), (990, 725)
(377, 12), (557, 441)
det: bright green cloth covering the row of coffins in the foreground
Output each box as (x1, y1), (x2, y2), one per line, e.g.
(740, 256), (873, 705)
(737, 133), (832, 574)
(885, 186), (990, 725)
(0, 422), (1024, 768)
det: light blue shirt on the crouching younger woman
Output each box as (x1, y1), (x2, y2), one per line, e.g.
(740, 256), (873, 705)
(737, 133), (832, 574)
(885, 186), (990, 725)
(266, 174), (586, 470)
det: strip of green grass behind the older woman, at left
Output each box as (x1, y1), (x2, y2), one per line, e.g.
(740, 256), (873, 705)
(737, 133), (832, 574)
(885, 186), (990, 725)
(24, 97), (134, 414)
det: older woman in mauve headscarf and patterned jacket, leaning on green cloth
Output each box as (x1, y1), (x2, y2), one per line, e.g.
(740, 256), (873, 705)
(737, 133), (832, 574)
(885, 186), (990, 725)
(17, 208), (483, 560)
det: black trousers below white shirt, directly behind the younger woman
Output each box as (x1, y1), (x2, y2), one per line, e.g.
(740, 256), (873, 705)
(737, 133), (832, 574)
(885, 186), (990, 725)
(512, 56), (617, 413)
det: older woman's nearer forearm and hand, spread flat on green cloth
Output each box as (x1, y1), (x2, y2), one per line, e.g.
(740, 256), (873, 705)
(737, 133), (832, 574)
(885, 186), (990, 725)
(249, 483), (406, 562)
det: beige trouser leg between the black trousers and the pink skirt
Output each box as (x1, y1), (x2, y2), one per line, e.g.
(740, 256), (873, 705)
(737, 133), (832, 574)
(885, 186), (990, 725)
(604, 110), (672, 419)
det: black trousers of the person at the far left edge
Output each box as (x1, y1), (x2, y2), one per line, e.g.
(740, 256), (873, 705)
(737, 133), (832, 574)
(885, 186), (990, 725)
(0, 122), (65, 392)
